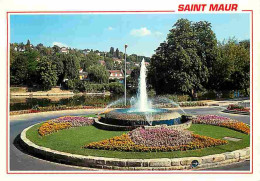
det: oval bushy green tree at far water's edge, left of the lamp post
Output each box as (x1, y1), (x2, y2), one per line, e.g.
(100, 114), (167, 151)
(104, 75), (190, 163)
(37, 56), (58, 90)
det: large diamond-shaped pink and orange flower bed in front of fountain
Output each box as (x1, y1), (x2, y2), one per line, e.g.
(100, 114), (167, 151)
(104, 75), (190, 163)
(84, 127), (228, 152)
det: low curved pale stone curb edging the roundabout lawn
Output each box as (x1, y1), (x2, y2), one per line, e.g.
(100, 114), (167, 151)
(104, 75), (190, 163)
(20, 123), (250, 170)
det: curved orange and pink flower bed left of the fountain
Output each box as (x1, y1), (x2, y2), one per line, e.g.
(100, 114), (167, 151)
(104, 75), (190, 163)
(38, 116), (94, 136)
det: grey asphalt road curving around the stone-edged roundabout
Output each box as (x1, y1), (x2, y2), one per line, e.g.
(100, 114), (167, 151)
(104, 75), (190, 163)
(9, 107), (250, 171)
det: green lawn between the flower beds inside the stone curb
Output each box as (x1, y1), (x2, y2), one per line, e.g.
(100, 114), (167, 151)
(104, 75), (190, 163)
(26, 124), (250, 158)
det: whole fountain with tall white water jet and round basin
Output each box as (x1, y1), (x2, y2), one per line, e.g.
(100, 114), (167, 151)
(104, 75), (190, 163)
(96, 59), (191, 130)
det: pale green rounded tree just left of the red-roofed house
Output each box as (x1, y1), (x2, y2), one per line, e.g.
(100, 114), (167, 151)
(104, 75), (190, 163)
(87, 65), (109, 84)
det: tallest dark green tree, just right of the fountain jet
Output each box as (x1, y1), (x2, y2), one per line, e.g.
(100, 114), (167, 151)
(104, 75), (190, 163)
(148, 19), (212, 96)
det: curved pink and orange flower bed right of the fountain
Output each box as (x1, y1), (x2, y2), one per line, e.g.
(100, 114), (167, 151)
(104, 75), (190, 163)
(192, 115), (250, 134)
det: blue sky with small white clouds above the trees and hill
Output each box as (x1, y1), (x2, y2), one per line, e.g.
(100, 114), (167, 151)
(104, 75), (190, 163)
(10, 13), (250, 56)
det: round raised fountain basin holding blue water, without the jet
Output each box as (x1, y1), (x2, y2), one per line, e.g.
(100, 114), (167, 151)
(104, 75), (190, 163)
(100, 109), (186, 127)
